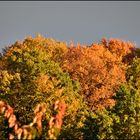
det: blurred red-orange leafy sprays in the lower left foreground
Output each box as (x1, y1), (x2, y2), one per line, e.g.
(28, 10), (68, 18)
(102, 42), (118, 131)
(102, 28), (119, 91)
(0, 101), (65, 139)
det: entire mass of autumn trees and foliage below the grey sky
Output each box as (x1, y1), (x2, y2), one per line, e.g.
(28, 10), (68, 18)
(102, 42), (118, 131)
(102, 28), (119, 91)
(0, 35), (140, 140)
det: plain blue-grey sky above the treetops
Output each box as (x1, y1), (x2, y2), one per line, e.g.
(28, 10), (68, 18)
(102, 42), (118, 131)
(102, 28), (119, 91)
(0, 1), (140, 51)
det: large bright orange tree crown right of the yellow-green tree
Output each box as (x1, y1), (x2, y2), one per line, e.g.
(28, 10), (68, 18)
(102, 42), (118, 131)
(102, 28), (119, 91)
(62, 39), (134, 110)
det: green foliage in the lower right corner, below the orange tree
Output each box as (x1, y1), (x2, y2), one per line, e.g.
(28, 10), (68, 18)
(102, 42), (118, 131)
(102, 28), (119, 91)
(88, 59), (140, 139)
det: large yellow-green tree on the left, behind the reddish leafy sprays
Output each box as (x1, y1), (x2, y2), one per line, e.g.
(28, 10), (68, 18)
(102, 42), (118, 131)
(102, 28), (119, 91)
(0, 38), (86, 138)
